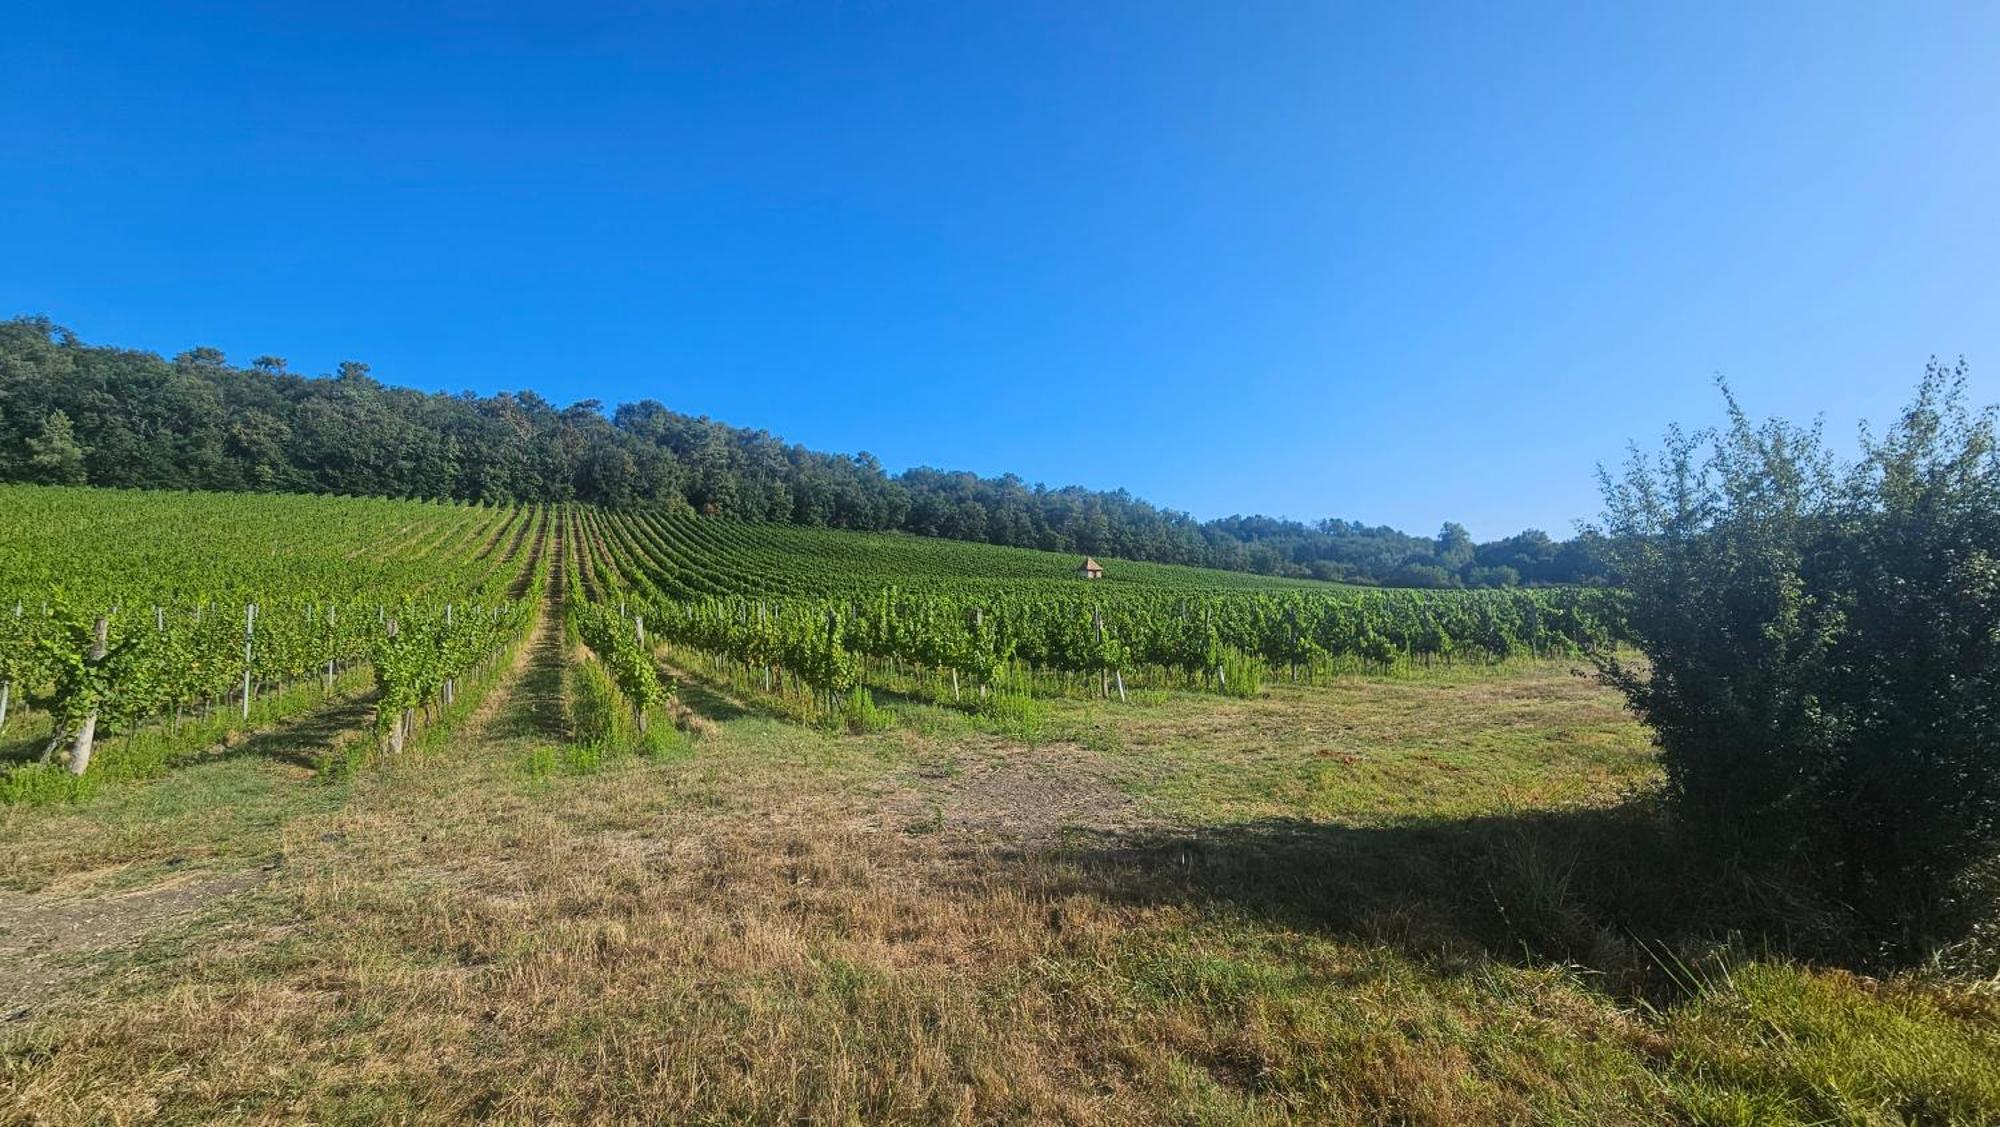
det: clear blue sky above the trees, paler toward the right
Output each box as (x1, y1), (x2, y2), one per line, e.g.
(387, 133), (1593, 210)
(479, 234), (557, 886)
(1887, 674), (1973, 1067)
(0, 2), (2000, 538)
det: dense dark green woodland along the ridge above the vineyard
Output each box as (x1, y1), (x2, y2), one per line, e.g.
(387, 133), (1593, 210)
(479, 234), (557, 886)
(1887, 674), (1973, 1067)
(0, 318), (1600, 587)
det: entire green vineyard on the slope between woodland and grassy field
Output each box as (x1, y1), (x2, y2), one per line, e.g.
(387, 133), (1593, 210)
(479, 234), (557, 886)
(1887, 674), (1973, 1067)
(0, 486), (1616, 797)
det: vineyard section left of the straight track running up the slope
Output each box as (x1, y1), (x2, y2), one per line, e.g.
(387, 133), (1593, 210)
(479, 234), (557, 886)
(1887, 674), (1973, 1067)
(0, 486), (556, 797)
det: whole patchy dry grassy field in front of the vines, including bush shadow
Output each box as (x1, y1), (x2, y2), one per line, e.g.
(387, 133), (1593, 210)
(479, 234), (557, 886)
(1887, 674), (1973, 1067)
(0, 587), (2000, 1123)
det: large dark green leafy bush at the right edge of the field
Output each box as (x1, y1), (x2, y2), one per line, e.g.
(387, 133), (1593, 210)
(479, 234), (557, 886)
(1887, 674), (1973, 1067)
(1600, 364), (2000, 945)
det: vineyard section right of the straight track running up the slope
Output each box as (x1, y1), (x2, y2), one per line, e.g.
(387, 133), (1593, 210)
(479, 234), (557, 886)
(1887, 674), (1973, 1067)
(568, 510), (1618, 715)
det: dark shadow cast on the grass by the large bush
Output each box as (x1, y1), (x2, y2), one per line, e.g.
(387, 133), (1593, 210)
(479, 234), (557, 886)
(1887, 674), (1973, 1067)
(1020, 801), (1870, 997)
